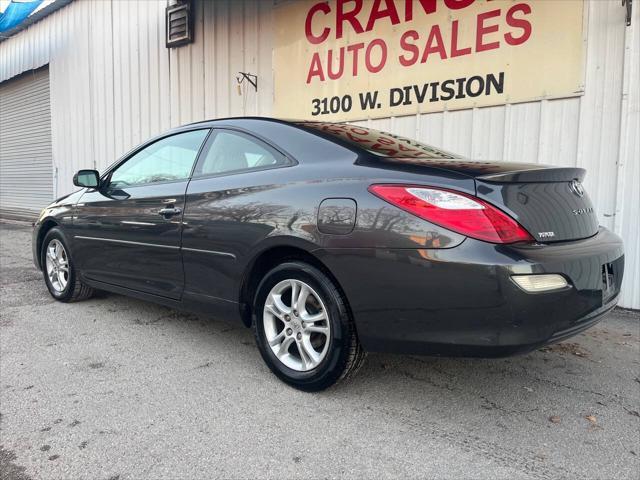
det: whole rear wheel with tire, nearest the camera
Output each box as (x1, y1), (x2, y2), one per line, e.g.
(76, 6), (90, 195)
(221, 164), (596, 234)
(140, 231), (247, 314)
(254, 261), (364, 391)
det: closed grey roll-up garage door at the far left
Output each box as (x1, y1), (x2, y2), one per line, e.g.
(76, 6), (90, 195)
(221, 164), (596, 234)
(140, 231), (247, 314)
(0, 68), (53, 215)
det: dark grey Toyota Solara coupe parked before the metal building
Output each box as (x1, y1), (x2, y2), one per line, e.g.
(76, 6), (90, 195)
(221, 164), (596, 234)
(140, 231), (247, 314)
(33, 118), (624, 391)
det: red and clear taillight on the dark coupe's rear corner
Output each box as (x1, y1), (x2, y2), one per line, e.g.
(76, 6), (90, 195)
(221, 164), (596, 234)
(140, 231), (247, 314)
(369, 185), (534, 243)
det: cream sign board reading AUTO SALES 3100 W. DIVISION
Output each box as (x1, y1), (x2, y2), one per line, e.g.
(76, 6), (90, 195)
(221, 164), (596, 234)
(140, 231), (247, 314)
(273, 0), (584, 121)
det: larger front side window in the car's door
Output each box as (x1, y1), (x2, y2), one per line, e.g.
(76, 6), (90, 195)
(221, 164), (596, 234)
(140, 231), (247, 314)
(109, 130), (209, 188)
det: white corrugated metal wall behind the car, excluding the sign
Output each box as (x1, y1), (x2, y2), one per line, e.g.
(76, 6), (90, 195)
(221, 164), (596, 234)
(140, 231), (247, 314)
(0, 0), (640, 308)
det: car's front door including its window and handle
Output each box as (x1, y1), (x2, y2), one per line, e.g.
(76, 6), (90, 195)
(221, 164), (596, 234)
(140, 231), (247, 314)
(73, 129), (209, 299)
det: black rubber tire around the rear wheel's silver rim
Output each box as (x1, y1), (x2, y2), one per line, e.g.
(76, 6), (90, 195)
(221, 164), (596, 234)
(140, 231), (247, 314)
(253, 261), (365, 392)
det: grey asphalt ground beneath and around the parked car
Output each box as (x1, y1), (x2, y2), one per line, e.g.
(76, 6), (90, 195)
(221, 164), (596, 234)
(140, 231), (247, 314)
(0, 218), (640, 480)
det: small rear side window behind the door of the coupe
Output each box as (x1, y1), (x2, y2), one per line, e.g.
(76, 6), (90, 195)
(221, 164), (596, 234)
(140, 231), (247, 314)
(193, 130), (286, 177)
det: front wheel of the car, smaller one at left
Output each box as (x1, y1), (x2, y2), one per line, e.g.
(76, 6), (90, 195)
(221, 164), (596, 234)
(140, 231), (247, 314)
(41, 228), (94, 302)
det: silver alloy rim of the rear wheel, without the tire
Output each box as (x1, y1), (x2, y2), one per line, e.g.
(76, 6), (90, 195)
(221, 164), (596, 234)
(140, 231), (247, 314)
(262, 279), (331, 372)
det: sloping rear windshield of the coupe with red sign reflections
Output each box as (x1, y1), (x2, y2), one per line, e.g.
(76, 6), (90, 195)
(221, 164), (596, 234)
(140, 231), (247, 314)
(296, 122), (460, 159)
